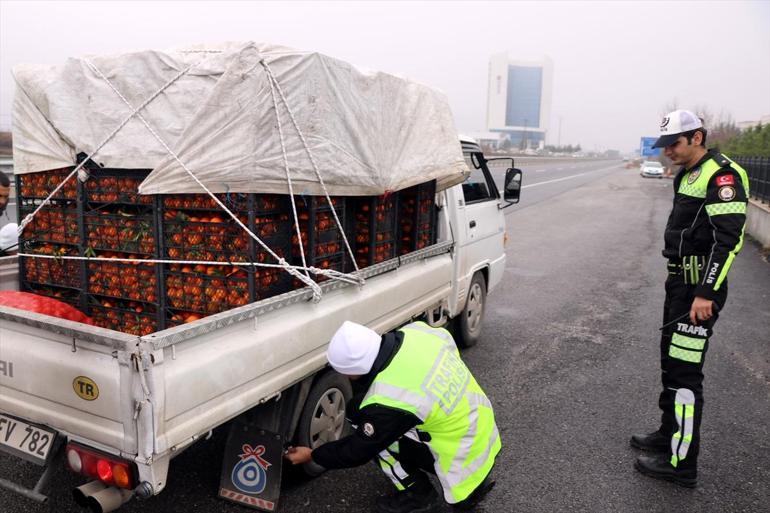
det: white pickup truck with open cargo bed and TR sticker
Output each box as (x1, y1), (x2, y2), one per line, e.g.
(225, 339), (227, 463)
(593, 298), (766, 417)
(0, 140), (521, 511)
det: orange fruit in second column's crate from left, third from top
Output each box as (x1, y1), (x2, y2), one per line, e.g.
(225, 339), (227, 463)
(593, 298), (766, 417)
(87, 252), (158, 303)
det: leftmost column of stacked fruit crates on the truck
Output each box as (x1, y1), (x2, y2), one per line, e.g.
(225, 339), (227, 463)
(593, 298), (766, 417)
(16, 168), (83, 308)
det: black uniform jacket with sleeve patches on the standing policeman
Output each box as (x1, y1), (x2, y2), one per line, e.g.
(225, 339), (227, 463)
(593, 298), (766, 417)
(663, 150), (747, 299)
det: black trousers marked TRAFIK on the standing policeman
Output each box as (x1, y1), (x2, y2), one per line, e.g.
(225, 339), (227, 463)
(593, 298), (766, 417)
(658, 266), (727, 469)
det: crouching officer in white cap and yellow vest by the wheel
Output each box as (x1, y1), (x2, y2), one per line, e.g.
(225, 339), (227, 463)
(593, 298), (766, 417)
(286, 321), (501, 513)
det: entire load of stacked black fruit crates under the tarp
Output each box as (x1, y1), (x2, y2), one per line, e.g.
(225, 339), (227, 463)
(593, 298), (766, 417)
(17, 165), (436, 335)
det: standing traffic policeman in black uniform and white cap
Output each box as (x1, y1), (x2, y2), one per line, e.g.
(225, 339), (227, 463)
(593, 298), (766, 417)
(631, 110), (749, 487)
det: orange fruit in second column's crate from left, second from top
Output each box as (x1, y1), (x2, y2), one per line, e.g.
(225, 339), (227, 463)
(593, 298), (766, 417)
(84, 208), (155, 255)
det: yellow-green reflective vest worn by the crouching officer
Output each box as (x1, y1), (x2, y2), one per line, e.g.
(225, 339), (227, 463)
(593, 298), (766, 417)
(361, 323), (501, 504)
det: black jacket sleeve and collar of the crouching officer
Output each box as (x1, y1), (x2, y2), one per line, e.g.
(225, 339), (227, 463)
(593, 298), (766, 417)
(312, 332), (422, 469)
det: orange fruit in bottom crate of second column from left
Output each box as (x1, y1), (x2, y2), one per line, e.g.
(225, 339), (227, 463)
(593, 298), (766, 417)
(88, 296), (158, 336)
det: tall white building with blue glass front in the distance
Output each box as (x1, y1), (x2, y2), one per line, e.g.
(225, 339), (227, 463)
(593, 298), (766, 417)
(487, 53), (553, 149)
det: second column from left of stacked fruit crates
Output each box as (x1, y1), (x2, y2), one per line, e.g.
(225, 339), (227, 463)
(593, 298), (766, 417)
(82, 168), (164, 335)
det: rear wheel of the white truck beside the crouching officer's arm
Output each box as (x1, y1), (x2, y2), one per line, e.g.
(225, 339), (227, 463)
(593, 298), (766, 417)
(297, 370), (353, 477)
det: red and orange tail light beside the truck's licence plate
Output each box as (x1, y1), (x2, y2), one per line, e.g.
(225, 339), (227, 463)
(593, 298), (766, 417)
(66, 443), (136, 490)
